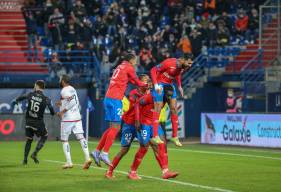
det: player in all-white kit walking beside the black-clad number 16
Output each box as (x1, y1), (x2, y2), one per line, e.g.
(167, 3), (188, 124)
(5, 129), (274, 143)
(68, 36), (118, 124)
(56, 75), (92, 169)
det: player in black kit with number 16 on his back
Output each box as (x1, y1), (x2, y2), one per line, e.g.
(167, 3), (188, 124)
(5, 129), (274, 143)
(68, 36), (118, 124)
(13, 80), (55, 165)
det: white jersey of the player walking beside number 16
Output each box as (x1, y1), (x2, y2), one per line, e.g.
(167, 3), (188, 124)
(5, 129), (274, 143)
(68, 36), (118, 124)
(61, 85), (81, 121)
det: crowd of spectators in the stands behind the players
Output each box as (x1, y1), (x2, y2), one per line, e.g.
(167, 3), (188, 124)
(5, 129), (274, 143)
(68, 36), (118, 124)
(23, 0), (264, 73)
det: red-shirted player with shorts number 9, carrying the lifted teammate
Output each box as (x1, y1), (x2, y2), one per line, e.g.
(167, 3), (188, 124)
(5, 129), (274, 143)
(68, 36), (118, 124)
(128, 86), (178, 180)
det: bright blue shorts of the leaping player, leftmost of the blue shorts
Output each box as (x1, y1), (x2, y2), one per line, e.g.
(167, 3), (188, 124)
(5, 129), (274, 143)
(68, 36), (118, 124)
(103, 97), (122, 122)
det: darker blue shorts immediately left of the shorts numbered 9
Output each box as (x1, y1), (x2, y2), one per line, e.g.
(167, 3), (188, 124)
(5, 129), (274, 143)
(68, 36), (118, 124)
(121, 123), (137, 147)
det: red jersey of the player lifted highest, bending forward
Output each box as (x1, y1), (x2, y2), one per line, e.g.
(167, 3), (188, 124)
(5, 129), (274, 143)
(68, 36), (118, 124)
(150, 58), (184, 87)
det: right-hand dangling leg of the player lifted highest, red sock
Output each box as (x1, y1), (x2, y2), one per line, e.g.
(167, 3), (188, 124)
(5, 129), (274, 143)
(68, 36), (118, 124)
(169, 94), (182, 147)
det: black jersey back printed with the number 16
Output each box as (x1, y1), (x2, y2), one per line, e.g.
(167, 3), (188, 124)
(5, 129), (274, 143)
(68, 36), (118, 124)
(26, 91), (50, 120)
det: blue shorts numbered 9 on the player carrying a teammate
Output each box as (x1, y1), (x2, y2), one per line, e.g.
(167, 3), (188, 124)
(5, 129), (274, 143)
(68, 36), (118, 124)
(137, 125), (164, 145)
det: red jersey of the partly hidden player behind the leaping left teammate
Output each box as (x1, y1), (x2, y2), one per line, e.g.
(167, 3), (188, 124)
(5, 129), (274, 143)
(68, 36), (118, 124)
(122, 89), (143, 125)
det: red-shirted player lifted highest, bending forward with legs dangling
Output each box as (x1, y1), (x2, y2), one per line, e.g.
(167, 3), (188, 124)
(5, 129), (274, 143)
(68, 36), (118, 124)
(150, 54), (193, 146)
